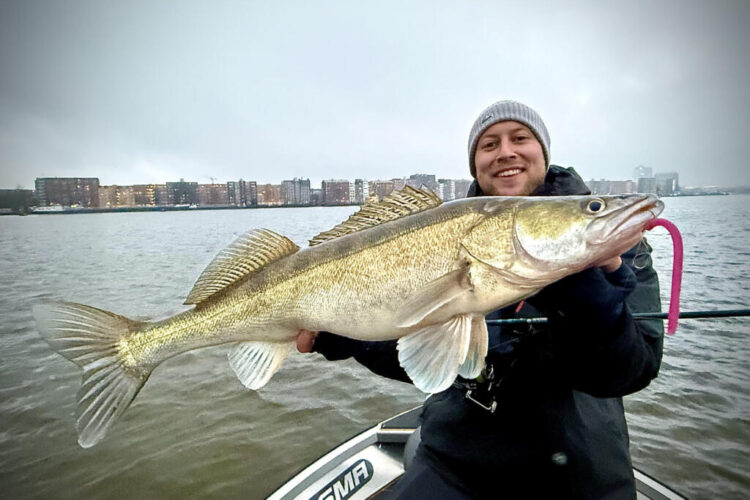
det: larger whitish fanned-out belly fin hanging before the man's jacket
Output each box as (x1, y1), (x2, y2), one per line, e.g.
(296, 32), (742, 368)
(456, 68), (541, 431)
(398, 315), (472, 393)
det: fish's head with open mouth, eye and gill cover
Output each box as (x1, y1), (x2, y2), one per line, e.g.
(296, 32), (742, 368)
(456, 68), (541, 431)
(464, 194), (664, 283)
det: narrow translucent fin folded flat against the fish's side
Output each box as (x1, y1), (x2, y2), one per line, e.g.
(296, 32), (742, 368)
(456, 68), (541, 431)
(394, 266), (472, 328)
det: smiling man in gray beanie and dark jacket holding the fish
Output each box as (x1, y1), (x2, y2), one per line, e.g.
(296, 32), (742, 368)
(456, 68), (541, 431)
(298, 101), (663, 499)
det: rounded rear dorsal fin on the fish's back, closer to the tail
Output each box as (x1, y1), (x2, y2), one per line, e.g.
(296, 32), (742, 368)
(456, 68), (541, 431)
(185, 229), (299, 304)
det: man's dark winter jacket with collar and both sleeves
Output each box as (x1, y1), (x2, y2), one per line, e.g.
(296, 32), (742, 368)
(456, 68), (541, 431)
(315, 165), (663, 498)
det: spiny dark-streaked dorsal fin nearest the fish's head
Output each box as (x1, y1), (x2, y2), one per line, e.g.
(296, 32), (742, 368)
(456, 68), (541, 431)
(310, 186), (442, 246)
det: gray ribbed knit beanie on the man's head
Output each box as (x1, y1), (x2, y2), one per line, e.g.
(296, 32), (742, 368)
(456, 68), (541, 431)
(469, 101), (549, 177)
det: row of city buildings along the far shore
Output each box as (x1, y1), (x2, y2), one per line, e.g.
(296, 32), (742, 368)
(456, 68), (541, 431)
(0, 165), (750, 215)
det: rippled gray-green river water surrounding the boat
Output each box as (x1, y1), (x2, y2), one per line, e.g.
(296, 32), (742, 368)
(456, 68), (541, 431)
(0, 195), (750, 499)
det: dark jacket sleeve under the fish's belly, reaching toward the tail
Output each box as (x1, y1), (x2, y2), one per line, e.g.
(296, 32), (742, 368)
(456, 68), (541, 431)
(313, 332), (411, 383)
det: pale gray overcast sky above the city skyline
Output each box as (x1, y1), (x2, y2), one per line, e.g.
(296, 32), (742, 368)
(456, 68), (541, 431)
(0, 0), (750, 188)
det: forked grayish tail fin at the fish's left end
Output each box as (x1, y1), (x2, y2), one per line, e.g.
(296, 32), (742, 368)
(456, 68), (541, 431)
(34, 302), (151, 448)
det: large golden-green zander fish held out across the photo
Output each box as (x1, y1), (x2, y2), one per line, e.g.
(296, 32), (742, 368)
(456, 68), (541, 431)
(34, 188), (663, 447)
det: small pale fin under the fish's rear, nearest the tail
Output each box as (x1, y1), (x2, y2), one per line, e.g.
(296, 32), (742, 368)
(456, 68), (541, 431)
(229, 342), (294, 390)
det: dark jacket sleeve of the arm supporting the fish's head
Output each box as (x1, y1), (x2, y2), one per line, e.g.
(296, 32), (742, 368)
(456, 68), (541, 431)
(540, 239), (664, 397)
